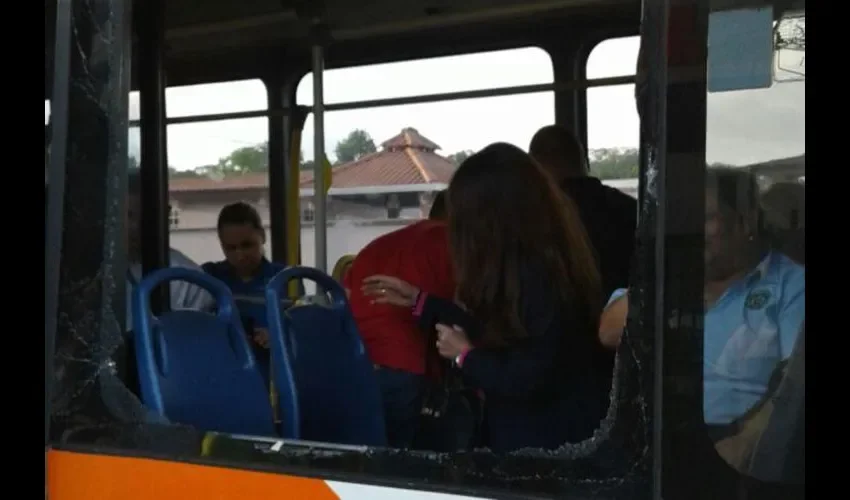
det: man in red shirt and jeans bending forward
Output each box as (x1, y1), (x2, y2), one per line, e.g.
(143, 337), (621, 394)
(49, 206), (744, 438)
(344, 192), (455, 448)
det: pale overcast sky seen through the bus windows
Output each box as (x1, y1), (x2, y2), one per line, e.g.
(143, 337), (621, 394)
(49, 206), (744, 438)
(45, 33), (805, 170)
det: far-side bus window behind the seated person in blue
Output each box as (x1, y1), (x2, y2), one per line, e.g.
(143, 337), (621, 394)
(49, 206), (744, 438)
(166, 80), (271, 264)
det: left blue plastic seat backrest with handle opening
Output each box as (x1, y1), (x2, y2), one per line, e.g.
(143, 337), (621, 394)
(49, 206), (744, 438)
(133, 267), (276, 436)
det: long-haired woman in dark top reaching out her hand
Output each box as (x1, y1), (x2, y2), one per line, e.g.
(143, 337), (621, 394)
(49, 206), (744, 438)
(362, 143), (605, 452)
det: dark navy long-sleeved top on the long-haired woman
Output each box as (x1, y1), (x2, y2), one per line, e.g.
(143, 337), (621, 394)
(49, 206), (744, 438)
(419, 266), (608, 452)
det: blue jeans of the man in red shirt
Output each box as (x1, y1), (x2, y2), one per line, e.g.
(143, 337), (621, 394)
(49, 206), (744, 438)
(375, 367), (425, 448)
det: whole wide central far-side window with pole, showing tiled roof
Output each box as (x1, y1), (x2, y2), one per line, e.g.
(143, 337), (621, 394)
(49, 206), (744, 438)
(297, 48), (554, 269)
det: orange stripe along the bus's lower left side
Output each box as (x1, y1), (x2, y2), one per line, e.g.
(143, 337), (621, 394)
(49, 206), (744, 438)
(47, 450), (339, 500)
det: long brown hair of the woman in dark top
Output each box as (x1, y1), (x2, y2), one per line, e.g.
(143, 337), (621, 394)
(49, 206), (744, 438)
(447, 143), (602, 343)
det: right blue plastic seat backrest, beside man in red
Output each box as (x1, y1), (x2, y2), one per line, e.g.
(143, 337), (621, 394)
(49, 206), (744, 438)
(266, 267), (387, 446)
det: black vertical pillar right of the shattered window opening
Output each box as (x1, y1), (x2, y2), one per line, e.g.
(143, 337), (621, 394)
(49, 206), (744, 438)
(644, 0), (805, 499)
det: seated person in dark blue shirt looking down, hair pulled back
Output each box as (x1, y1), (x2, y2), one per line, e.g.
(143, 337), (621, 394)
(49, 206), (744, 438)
(202, 202), (284, 386)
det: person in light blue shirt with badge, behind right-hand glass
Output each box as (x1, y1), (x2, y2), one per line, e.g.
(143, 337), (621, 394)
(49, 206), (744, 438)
(599, 168), (806, 430)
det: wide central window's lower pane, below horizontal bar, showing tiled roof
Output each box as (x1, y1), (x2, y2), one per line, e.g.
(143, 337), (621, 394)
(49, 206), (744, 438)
(301, 92), (555, 269)
